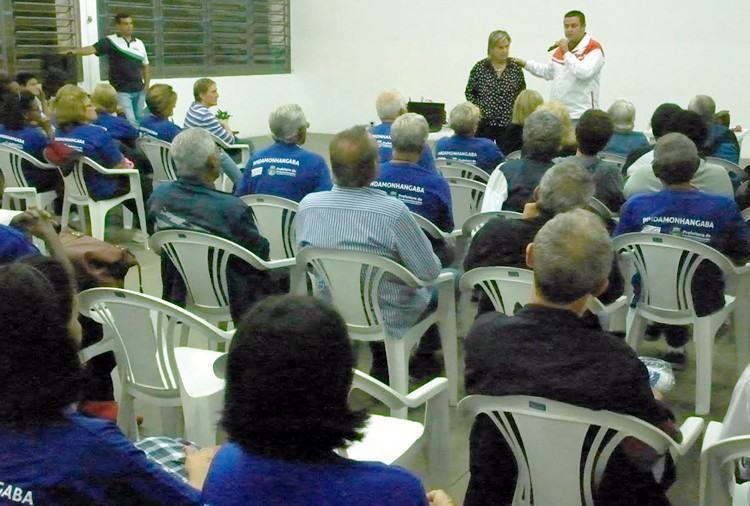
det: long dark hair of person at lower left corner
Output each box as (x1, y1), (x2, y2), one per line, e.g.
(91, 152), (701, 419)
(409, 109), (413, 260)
(0, 260), (83, 429)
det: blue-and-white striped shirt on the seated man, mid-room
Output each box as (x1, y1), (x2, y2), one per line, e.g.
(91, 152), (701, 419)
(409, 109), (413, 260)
(295, 185), (440, 337)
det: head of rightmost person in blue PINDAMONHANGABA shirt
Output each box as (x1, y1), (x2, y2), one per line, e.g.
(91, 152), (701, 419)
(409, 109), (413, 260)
(653, 132), (701, 185)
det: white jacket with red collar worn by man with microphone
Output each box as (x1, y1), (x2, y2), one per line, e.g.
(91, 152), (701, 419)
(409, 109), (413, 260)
(525, 34), (604, 119)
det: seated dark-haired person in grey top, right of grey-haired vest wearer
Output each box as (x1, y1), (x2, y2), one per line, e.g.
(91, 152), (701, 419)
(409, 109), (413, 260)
(563, 109), (625, 213)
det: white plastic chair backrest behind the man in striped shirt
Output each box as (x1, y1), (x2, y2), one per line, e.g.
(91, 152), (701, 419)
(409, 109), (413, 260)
(292, 247), (424, 339)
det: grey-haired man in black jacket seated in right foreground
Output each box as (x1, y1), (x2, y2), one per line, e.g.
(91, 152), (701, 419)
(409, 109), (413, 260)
(464, 209), (677, 506)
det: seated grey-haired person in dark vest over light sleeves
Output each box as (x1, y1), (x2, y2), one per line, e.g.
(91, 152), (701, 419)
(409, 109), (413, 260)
(500, 110), (562, 212)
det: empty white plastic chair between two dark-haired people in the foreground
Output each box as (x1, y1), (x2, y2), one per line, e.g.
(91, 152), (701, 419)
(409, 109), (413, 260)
(79, 288), (232, 444)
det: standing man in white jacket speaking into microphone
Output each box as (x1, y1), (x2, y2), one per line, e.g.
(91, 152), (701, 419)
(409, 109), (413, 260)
(513, 11), (604, 122)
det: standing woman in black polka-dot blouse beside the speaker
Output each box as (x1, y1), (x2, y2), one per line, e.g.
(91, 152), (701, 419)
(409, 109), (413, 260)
(464, 30), (526, 145)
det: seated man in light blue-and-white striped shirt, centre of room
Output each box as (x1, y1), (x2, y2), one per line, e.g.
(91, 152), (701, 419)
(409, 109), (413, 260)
(295, 127), (440, 379)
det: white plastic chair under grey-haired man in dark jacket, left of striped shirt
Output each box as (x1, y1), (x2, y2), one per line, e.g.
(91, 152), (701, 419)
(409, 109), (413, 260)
(151, 230), (294, 324)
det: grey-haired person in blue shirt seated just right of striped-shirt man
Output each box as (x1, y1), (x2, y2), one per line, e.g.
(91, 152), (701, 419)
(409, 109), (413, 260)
(370, 112), (456, 266)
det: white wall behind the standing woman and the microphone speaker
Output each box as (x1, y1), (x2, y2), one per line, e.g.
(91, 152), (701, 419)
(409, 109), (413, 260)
(81, 0), (750, 135)
